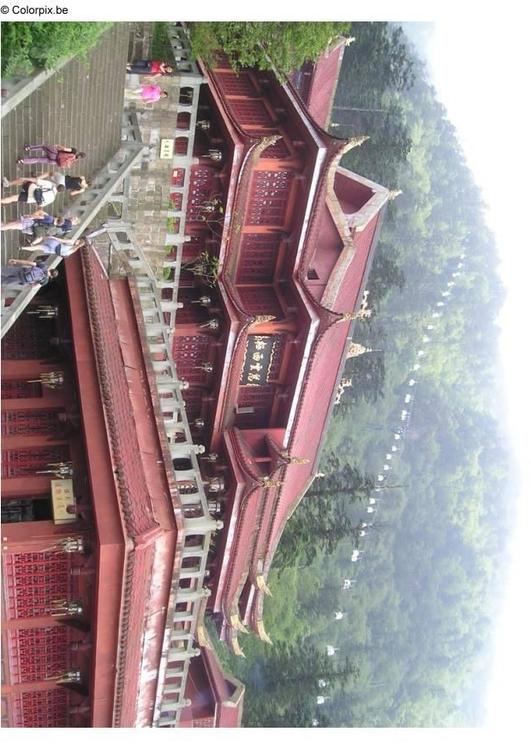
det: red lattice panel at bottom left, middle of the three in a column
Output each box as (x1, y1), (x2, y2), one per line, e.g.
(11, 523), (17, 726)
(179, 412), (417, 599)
(7, 625), (69, 682)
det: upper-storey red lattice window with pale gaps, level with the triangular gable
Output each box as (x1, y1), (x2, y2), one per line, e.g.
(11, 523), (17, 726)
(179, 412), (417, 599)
(246, 169), (293, 227)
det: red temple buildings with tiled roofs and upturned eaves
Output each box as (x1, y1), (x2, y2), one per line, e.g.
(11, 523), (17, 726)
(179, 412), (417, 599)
(2, 27), (389, 727)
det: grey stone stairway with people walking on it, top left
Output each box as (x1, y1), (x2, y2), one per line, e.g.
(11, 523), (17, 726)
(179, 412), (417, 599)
(2, 23), (135, 264)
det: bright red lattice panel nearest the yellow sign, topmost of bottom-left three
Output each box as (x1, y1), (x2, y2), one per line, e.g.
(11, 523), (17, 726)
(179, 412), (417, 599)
(4, 551), (77, 618)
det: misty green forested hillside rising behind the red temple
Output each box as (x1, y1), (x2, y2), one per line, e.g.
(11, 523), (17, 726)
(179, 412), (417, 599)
(206, 23), (513, 727)
